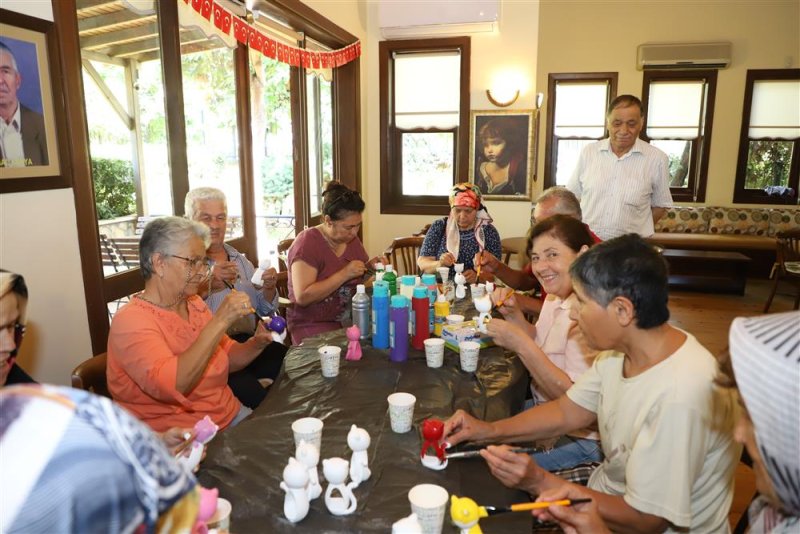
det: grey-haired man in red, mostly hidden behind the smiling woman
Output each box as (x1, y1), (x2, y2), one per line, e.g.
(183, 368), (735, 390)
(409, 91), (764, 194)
(480, 186), (600, 313)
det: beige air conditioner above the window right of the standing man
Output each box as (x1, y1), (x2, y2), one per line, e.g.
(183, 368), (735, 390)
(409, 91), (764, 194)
(636, 42), (731, 70)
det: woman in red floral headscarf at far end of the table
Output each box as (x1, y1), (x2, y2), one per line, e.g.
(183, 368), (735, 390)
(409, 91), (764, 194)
(417, 183), (502, 284)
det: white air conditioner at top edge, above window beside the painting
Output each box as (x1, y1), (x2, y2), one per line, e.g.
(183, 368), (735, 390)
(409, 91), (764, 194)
(378, 0), (501, 39)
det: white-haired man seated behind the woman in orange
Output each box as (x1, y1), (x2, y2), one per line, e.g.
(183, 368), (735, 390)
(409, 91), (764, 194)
(184, 187), (286, 408)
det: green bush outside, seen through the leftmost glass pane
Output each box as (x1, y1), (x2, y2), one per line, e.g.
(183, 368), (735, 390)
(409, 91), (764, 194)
(92, 158), (136, 219)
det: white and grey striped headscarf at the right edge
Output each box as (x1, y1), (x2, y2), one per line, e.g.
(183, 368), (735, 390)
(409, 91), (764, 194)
(730, 312), (800, 516)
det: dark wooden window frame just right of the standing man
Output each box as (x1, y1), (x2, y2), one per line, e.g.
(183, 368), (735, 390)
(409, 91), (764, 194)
(639, 69), (717, 202)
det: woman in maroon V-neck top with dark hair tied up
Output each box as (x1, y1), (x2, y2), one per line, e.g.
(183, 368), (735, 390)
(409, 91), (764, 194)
(287, 182), (386, 345)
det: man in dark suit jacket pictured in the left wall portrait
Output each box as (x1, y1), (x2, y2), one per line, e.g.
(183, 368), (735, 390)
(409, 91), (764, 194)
(0, 41), (49, 167)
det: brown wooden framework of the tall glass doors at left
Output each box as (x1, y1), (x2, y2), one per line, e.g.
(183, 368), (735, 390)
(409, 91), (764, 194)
(58, 0), (361, 354)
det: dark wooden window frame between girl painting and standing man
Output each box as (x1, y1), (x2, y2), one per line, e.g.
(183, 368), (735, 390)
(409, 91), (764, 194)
(544, 72), (619, 189)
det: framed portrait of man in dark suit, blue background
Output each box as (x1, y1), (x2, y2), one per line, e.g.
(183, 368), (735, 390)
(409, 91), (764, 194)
(0, 9), (71, 193)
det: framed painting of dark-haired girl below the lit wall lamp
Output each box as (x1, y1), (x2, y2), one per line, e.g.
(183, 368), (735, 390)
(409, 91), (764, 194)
(469, 110), (535, 201)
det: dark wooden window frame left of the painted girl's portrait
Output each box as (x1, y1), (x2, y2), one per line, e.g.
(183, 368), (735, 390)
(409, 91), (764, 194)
(379, 37), (470, 215)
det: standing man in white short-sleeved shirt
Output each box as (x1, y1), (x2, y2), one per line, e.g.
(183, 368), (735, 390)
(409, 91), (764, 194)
(567, 95), (672, 240)
